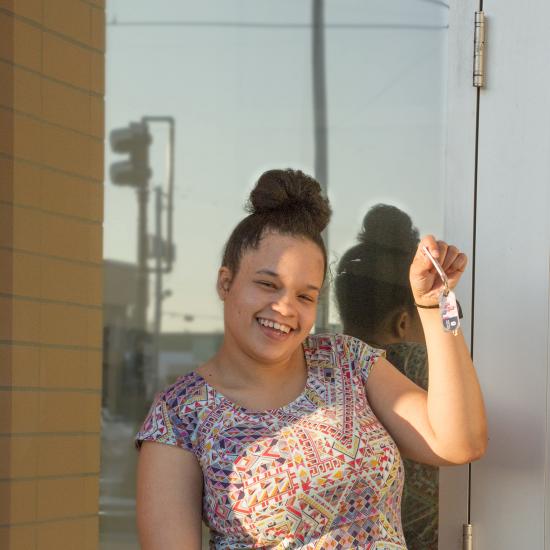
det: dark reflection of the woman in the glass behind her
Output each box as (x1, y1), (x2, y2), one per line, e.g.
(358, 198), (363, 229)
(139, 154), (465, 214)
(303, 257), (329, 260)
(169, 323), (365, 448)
(335, 204), (448, 550)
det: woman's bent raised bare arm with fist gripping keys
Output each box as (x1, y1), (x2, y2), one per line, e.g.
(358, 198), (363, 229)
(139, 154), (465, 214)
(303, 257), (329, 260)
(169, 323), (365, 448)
(366, 236), (487, 465)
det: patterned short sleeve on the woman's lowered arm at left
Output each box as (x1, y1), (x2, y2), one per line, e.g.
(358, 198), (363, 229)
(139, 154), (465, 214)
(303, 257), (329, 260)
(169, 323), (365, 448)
(135, 392), (195, 451)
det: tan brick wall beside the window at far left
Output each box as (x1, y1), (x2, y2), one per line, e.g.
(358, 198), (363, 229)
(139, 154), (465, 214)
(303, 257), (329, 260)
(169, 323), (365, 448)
(0, 0), (105, 550)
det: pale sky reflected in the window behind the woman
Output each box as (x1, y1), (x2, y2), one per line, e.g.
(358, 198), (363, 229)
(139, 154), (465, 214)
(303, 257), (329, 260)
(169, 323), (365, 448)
(104, 0), (448, 331)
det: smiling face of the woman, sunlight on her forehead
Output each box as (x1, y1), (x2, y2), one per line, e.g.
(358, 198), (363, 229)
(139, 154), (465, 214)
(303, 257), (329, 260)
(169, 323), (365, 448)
(218, 233), (324, 363)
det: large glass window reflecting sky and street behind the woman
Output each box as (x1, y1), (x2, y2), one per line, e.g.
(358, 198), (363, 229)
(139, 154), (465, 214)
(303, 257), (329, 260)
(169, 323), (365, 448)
(101, 0), (448, 550)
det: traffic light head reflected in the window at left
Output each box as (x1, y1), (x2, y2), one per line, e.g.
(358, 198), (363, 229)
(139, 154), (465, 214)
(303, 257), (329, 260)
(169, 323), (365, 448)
(110, 122), (152, 187)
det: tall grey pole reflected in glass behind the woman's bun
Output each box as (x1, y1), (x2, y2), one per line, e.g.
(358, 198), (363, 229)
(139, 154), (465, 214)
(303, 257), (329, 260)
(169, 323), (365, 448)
(311, 0), (329, 332)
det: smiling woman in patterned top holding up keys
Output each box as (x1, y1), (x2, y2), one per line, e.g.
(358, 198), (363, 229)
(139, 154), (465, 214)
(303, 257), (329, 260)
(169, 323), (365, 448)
(137, 170), (486, 550)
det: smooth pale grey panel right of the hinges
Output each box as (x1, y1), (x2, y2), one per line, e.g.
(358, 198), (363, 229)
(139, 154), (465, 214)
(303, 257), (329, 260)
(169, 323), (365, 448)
(472, 0), (550, 550)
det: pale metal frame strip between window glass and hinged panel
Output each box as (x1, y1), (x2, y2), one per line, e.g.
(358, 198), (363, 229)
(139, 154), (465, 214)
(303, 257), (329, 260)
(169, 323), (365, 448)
(438, 0), (478, 550)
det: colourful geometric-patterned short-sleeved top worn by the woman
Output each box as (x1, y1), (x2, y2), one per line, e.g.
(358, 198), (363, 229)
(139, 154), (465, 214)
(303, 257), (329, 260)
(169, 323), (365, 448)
(136, 335), (406, 550)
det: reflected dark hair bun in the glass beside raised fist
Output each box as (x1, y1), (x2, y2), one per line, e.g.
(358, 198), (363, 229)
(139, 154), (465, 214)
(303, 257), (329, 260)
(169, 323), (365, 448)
(357, 204), (419, 251)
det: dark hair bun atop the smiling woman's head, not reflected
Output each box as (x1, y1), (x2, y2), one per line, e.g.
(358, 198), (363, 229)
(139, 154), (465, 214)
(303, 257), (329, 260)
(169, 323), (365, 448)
(247, 168), (331, 233)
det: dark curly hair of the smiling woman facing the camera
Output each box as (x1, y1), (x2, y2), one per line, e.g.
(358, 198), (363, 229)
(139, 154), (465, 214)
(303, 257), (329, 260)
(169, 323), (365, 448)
(222, 168), (332, 280)
